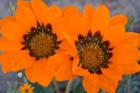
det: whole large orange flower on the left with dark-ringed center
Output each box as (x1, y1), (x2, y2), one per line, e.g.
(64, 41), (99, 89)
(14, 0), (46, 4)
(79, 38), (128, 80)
(0, 0), (73, 86)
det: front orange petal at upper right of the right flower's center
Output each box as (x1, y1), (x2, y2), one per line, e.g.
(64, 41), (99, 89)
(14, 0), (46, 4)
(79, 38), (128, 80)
(103, 25), (125, 47)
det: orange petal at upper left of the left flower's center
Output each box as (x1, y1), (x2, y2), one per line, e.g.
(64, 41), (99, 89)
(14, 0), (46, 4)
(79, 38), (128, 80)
(16, 7), (37, 31)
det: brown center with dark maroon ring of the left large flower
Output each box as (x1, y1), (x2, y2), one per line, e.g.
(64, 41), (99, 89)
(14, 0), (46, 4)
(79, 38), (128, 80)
(22, 24), (61, 59)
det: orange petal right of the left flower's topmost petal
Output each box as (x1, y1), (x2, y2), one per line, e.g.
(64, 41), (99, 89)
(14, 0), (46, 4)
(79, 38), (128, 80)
(45, 5), (66, 40)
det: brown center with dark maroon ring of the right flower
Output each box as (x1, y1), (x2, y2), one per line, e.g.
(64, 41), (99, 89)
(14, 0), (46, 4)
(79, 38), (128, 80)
(75, 31), (113, 74)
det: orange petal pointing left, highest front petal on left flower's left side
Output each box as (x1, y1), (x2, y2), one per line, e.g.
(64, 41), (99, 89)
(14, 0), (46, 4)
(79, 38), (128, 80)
(1, 22), (26, 42)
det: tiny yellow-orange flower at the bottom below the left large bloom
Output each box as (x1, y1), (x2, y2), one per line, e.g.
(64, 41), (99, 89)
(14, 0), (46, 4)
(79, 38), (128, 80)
(19, 83), (33, 93)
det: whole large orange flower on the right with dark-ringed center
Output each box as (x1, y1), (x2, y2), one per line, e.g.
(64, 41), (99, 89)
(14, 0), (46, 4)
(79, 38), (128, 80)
(64, 4), (140, 93)
